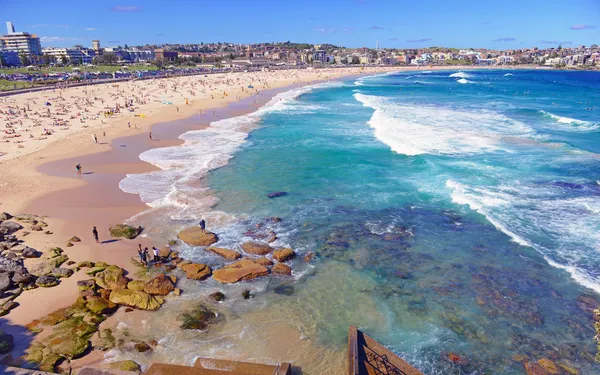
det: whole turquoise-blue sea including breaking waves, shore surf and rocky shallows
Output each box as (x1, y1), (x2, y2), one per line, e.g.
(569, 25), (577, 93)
(121, 70), (600, 374)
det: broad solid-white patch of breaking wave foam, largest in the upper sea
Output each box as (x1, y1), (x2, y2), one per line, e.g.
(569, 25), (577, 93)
(354, 93), (533, 155)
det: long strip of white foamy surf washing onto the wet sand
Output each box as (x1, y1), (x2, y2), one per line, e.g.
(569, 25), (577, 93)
(119, 81), (342, 221)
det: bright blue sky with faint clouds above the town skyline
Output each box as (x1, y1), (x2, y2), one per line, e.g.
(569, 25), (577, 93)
(0, 0), (600, 49)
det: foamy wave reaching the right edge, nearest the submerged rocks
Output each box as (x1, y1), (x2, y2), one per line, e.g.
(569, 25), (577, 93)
(446, 180), (600, 292)
